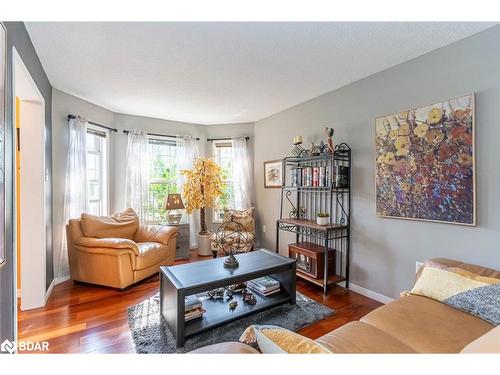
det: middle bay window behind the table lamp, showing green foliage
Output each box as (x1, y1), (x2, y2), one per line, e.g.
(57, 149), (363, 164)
(148, 138), (179, 223)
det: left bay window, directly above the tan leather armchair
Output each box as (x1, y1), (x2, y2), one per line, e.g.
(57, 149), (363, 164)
(87, 126), (108, 215)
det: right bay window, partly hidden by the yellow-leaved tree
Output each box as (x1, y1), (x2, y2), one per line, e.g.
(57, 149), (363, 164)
(213, 141), (234, 223)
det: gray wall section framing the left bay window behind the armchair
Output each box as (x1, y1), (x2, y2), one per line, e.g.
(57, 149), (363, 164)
(52, 89), (114, 276)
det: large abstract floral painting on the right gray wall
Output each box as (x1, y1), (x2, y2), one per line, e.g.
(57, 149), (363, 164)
(375, 94), (476, 225)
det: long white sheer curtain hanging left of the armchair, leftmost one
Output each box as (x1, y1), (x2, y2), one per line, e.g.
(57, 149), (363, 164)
(55, 118), (88, 278)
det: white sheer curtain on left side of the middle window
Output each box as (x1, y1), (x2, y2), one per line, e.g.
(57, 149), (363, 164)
(125, 130), (149, 223)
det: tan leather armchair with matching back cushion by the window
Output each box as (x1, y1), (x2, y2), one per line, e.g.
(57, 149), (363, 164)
(66, 209), (178, 289)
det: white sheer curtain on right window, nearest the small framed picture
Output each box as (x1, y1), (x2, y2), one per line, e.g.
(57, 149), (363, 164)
(231, 137), (253, 210)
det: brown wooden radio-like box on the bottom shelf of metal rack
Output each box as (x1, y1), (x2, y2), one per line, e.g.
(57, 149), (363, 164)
(288, 242), (335, 278)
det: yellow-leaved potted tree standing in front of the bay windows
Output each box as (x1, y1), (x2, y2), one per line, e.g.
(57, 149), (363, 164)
(181, 158), (223, 255)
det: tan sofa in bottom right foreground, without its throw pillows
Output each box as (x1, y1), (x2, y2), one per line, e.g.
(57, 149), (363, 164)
(193, 258), (500, 353)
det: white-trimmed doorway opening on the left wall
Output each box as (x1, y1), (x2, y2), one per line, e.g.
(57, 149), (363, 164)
(12, 48), (47, 310)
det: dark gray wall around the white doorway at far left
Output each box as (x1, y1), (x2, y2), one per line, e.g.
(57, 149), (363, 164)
(0, 22), (53, 342)
